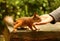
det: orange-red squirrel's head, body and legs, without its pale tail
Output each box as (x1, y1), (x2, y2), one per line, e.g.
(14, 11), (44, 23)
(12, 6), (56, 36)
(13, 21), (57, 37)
(14, 13), (41, 31)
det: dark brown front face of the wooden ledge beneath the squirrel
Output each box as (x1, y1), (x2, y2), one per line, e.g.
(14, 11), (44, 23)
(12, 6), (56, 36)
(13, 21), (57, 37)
(10, 31), (60, 41)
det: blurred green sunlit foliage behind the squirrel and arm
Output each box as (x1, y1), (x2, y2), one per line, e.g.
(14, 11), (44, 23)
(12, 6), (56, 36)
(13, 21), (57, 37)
(0, 0), (60, 34)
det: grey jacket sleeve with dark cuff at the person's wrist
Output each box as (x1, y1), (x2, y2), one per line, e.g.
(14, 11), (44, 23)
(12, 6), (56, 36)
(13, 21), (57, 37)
(49, 7), (60, 24)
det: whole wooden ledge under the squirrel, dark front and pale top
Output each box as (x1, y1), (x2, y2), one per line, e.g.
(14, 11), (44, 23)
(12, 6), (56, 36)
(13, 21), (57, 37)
(4, 23), (60, 41)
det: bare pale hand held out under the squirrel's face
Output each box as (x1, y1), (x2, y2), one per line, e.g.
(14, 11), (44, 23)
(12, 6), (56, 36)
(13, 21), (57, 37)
(33, 14), (53, 25)
